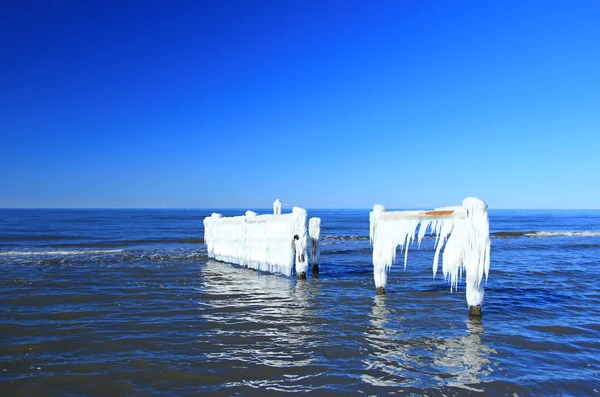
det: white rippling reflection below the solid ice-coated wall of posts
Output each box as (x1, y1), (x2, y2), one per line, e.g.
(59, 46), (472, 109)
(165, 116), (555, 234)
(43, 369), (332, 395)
(198, 260), (319, 389)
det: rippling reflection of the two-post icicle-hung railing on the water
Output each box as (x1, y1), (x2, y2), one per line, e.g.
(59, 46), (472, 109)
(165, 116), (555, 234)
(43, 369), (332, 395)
(362, 295), (496, 391)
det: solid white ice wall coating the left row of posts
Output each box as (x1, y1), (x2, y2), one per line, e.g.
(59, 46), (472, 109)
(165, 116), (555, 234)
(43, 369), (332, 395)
(204, 207), (308, 276)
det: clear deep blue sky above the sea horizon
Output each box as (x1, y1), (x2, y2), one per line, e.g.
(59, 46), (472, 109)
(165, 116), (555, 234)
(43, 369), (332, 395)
(0, 0), (600, 209)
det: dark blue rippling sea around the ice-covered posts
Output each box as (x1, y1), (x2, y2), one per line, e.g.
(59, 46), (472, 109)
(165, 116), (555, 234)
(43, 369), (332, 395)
(0, 209), (600, 397)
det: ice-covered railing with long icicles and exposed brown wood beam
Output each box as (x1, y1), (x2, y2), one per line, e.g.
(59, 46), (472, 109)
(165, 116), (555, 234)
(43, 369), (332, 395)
(370, 197), (490, 315)
